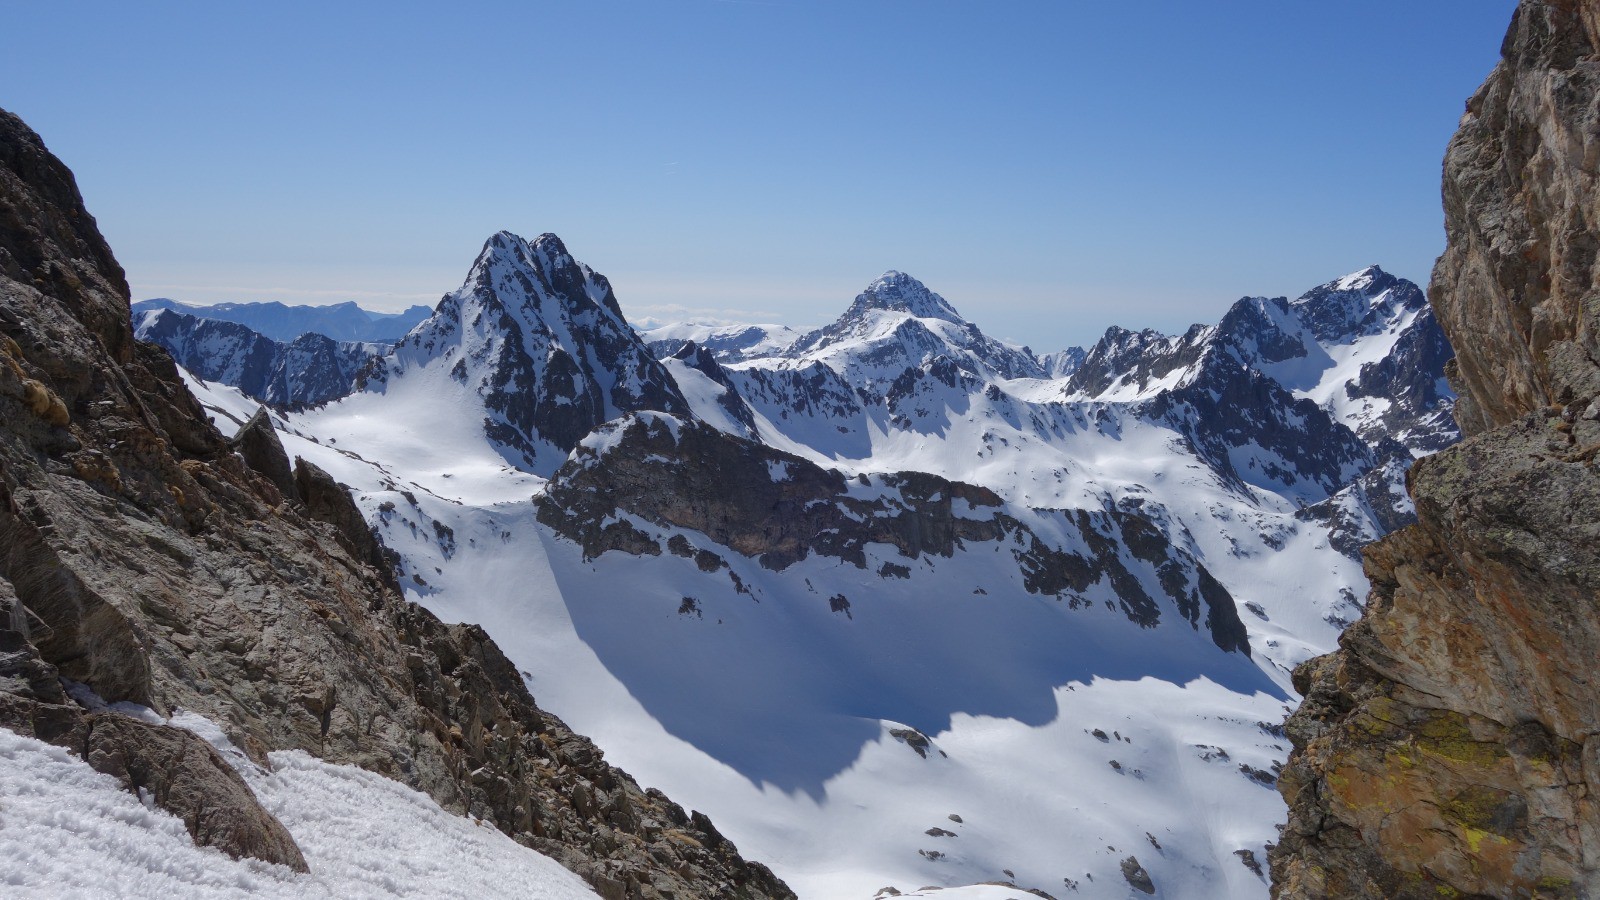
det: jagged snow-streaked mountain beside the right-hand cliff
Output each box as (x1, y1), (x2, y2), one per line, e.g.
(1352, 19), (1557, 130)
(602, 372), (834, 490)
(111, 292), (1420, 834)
(1067, 266), (1459, 538)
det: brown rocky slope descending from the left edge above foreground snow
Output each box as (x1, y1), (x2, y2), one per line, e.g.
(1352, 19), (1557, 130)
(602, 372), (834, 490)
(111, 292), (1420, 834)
(0, 110), (792, 900)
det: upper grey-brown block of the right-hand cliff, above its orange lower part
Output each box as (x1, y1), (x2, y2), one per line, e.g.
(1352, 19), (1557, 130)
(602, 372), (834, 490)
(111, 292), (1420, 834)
(1432, 0), (1600, 432)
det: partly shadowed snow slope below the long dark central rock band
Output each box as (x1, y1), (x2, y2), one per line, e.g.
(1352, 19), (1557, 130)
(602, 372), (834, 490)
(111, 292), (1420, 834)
(184, 374), (1312, 900)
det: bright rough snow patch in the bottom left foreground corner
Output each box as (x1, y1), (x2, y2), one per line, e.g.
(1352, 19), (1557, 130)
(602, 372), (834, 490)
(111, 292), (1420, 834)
(0, 716), (595, 900)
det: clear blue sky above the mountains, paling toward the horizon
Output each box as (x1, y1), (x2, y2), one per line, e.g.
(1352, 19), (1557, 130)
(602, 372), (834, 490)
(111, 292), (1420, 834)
(0, 0), (1514, 351)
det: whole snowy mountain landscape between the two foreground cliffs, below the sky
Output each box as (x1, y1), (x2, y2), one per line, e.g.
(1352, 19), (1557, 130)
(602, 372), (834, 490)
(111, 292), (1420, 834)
(141, 232), (1458, 897)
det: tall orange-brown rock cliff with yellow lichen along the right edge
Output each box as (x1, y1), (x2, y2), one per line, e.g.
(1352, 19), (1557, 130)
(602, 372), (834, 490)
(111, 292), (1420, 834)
(1272, 0), (1600, 898)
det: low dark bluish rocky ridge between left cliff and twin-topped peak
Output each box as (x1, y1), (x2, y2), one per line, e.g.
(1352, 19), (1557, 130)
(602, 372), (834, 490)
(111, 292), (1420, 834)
(134, 309), (377, 408)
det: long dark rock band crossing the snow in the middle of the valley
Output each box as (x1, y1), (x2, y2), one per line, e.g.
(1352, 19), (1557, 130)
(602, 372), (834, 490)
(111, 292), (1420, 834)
(539, 413), (1250, 655)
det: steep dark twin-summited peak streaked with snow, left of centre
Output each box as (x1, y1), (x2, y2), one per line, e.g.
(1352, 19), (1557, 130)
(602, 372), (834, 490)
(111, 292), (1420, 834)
(382, 232), (690, 476)
